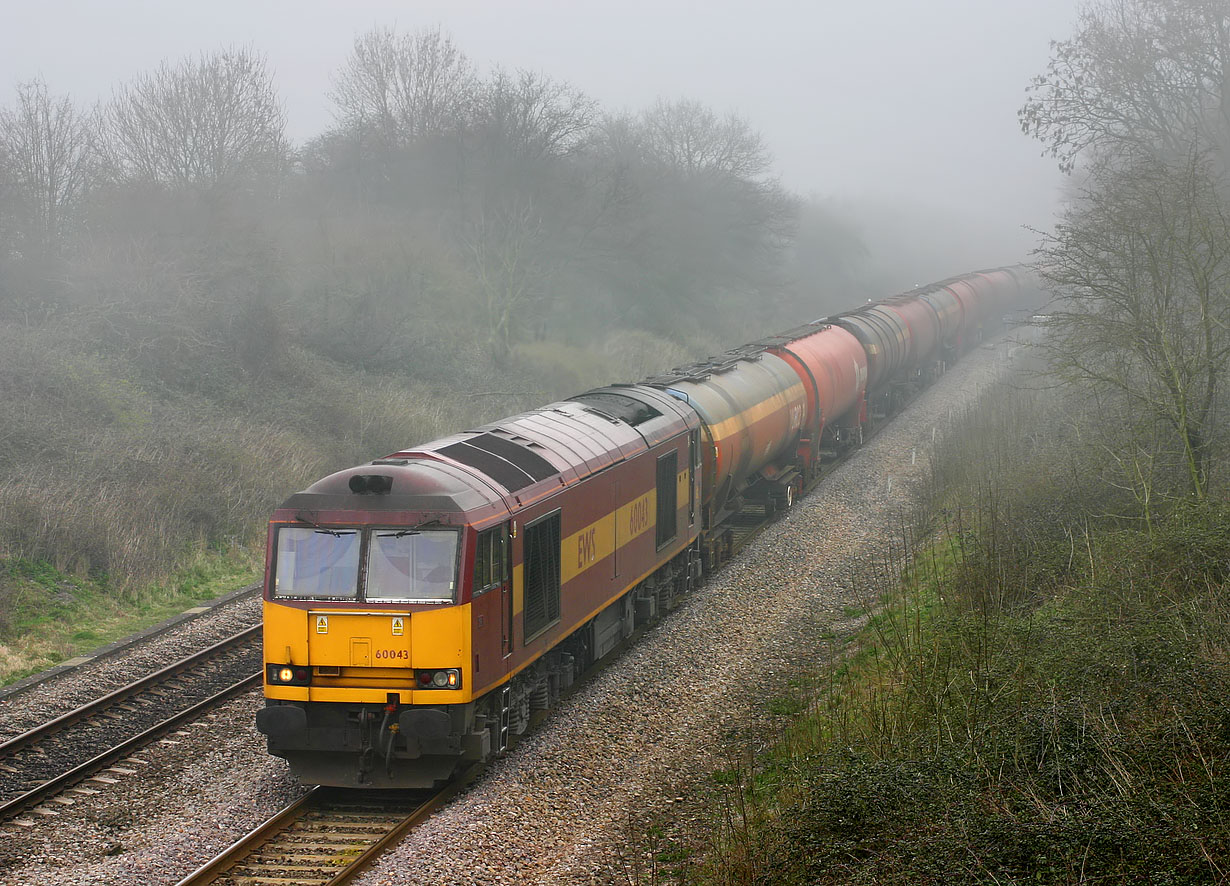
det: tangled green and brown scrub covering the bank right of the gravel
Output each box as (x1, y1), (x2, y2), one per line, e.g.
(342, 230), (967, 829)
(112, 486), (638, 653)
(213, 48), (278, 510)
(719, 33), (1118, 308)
(669, 390), (1230, 885)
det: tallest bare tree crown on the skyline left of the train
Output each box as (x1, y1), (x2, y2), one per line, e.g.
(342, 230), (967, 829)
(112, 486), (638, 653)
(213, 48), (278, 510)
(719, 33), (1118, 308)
(330, 28), (474, 148)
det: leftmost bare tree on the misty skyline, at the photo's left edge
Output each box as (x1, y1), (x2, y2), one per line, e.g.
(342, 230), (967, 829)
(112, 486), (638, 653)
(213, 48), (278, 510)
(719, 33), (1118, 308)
(0, 80), (97, 253)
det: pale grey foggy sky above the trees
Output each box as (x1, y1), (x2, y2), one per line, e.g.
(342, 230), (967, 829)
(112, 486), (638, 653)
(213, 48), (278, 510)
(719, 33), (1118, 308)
(0, 0), (1075, 272)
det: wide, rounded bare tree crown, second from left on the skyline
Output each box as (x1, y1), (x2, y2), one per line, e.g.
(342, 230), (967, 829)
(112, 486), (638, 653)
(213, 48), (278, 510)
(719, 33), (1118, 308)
(106, 49), (288, 191)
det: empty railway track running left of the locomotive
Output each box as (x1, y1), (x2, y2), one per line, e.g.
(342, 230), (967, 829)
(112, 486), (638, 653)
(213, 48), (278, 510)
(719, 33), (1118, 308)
(0, 625), (261, 821)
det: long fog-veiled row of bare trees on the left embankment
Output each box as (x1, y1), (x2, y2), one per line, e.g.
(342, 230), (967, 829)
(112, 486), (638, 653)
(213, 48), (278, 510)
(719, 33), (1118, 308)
(0, 28), (859, 393)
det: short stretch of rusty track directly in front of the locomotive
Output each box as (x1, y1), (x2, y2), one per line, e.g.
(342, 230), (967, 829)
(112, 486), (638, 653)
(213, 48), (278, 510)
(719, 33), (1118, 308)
(177, 765), (482, 886)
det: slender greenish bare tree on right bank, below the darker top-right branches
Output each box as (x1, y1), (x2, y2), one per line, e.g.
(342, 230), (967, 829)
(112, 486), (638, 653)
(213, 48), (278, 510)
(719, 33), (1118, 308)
(1039, 155), (1230, 498)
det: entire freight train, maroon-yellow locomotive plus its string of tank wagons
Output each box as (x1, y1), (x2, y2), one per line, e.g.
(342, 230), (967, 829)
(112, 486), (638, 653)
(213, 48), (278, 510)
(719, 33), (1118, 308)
(257, 267), (1037, 788)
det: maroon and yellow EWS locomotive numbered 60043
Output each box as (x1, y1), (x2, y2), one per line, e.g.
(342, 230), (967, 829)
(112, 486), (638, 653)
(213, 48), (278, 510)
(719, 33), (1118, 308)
(257, 386), (700, 786)
